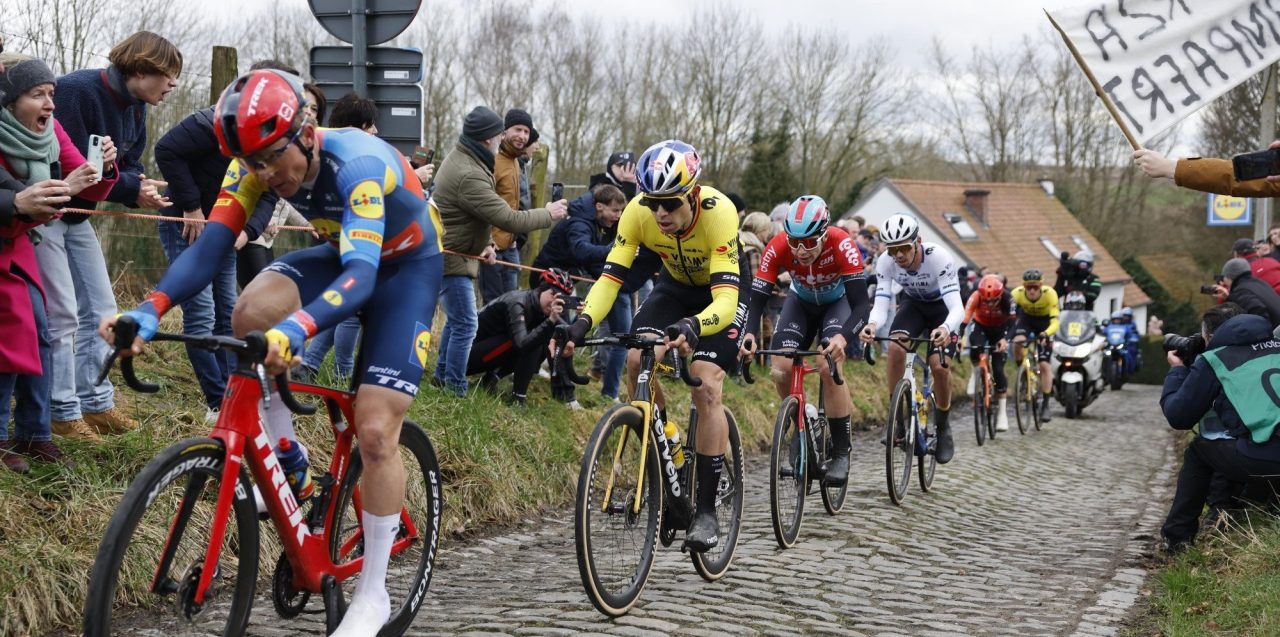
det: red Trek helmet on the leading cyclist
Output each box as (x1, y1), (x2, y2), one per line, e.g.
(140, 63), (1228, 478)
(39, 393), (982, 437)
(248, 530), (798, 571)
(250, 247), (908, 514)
(214, 69), (307, 157)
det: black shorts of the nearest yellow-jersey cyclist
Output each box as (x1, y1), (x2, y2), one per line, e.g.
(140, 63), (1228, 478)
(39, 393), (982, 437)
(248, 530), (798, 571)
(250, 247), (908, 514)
(631, 270), (750, 375)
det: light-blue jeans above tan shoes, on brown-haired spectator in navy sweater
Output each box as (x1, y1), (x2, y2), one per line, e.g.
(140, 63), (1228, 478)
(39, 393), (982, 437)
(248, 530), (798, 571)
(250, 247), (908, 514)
(36, 220), (116, 421)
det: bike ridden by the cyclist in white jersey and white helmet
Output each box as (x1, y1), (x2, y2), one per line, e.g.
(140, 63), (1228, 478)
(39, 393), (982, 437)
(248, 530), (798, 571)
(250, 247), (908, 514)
(868, 336), (947, 505)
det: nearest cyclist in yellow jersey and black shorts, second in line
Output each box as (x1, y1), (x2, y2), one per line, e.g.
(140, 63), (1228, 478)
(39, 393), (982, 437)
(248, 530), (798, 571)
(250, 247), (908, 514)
(564, 139), (750, 551)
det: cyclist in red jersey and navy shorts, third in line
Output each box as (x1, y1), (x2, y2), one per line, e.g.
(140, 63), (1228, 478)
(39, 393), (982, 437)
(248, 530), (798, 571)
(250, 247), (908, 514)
(740, 194), (870, 486)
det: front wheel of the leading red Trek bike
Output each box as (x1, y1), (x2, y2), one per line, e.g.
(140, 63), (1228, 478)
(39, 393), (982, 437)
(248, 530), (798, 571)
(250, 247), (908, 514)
(84, 437), (259, 637)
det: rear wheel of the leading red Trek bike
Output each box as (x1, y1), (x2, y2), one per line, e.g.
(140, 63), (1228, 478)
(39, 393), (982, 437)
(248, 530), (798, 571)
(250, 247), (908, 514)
(326, 421), (443, 637)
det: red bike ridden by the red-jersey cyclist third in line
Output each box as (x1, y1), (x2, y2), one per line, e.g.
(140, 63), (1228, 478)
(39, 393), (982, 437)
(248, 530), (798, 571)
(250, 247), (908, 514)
(742, 339), (849, 549)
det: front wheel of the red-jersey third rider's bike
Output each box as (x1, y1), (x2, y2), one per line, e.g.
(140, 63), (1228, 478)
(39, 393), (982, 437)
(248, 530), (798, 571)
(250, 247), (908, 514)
(769, 397), (810, 549)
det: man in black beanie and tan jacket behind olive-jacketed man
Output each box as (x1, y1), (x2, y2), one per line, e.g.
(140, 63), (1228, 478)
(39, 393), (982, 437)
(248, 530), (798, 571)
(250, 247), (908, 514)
(480, 109), (534, 304)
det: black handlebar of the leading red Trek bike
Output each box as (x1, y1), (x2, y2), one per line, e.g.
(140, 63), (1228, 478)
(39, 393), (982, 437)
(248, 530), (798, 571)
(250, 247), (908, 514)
(97, 316), (316, 416)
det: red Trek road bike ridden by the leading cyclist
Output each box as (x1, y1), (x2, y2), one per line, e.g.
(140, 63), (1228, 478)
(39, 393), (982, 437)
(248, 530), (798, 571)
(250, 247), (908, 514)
(84, 317), (440, 637)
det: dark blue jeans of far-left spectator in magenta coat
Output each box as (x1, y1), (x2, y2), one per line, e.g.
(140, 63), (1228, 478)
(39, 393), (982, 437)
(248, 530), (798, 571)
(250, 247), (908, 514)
(0, 281), (54, 443)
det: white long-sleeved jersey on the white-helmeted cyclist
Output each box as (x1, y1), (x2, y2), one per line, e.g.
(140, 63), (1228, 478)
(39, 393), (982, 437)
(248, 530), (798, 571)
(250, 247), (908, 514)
(870, 242), (964, 334)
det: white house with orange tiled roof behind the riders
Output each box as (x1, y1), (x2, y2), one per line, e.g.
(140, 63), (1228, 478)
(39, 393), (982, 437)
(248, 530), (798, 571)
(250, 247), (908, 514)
(845, 178), (1151, 326)
